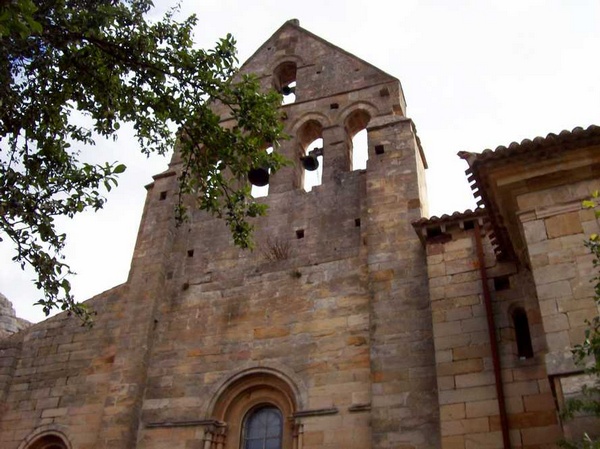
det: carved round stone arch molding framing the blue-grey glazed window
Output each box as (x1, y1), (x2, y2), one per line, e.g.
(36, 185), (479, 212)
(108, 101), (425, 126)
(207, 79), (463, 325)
(209, 368), (301, 449)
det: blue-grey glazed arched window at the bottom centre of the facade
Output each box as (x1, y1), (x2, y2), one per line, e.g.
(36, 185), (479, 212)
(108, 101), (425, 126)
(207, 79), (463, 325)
(242, 405), (283, 449)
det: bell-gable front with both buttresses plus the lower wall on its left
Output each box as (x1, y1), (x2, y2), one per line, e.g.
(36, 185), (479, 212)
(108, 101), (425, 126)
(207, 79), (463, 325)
(0, 19), (439, 449)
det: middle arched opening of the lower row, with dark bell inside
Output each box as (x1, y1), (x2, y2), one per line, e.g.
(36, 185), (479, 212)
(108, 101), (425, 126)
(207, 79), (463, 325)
(297, 120), (323, 192)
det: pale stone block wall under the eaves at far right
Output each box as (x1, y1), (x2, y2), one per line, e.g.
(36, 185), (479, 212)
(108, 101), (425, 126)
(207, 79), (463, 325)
(518, 180), (600, 437)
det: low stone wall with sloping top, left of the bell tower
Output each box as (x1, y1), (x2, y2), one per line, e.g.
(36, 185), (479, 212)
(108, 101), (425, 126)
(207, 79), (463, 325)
(0, 288), (127, 449)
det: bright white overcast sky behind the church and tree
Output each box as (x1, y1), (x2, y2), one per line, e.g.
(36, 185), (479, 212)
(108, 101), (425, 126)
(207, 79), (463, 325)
(0, 0), (600, 321)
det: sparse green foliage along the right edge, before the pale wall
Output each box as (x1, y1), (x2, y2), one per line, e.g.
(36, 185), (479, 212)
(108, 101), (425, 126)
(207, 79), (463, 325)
(561, 191), (600, 449)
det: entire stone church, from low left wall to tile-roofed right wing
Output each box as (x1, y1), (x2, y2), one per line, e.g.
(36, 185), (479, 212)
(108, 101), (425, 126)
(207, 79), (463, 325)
(0, 21), (600, 449)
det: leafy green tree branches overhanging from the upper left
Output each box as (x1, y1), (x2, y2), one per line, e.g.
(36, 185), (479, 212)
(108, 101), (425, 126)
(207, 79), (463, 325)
(0, 0), (283, 319)
